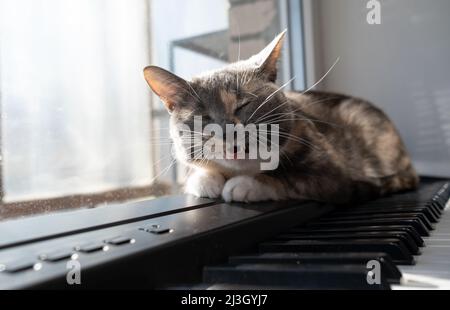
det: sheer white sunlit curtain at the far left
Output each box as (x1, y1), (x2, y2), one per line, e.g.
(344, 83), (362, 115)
(0, 0), (152, 201)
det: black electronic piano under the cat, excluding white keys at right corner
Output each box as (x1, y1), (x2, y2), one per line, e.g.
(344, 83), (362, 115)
(0, 179), (450, 289)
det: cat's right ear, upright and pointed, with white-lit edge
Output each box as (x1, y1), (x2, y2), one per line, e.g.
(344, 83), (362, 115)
(254, 30), (287, 82)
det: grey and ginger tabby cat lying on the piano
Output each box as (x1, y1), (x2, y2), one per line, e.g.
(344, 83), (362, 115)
(144, 32), (419, 204)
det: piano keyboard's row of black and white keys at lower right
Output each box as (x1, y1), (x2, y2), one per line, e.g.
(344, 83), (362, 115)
(193, 181), (450, 290)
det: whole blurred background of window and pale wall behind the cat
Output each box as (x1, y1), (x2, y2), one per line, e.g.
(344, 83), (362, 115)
(0, 0), (450, 213)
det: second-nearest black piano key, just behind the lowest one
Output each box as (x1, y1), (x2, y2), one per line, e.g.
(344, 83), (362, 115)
(229, 252), (402, 284)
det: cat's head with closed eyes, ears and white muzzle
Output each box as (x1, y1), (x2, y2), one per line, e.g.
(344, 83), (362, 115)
(144, 31), (292, 173)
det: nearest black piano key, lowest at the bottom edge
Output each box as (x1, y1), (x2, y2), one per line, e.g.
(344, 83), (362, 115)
(203, 264), (390, 290)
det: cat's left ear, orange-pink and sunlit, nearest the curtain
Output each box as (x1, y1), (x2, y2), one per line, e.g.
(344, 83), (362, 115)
(144, 66), (188, 113)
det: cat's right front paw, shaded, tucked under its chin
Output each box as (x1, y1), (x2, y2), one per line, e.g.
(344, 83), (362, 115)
(222, 176), (277, 202)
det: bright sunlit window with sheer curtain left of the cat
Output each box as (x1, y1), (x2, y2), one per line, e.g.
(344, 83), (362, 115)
(0, 0), (296, 219)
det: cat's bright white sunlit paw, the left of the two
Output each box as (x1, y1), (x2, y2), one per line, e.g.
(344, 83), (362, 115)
(185, 171), (225, 199)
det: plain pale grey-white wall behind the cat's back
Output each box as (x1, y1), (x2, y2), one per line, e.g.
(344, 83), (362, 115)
(314, 0), (450, 176)
